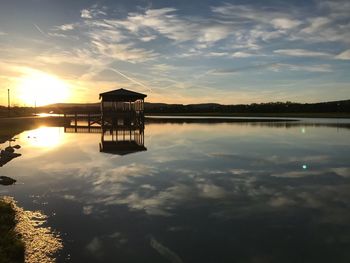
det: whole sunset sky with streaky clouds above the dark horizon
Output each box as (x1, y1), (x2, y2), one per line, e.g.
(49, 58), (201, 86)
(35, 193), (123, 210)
(0, 0), (350, 106)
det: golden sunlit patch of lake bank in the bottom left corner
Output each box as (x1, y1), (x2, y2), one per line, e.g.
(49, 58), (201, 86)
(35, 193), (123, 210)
(0, 196), (63, 263)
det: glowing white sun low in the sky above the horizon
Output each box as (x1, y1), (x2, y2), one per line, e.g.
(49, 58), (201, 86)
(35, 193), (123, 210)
(17, 71), (70, 106)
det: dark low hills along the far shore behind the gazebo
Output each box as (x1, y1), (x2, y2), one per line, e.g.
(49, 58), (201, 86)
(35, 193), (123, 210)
(38, 100), (350, 114)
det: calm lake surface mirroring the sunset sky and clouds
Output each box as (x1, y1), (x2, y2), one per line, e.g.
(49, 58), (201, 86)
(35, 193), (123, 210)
(0, 120), (350, 263)
